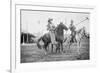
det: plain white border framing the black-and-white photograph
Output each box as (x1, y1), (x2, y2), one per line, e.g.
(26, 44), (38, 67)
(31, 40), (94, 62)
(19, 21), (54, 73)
(11, 2), (96, 73)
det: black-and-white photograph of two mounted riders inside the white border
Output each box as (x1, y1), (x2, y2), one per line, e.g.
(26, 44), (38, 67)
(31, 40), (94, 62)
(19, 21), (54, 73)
(20, 9), (90, 63)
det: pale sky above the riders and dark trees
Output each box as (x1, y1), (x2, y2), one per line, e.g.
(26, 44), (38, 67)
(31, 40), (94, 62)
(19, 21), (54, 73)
(21, 10), (90, 35)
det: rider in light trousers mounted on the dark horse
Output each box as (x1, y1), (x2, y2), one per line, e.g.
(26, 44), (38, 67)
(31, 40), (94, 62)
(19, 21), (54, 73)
(47, 18), (57, 44)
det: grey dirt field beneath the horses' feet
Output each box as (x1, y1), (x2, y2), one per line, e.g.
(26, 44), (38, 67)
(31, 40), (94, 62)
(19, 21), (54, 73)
(21, 39), (89, 63)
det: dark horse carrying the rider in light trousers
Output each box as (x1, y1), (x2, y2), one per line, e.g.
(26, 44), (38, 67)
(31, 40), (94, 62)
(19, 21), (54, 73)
(37, 23), (68, 52)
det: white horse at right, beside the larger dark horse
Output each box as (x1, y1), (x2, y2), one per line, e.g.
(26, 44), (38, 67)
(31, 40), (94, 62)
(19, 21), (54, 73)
(64, 27), (88, 54)
